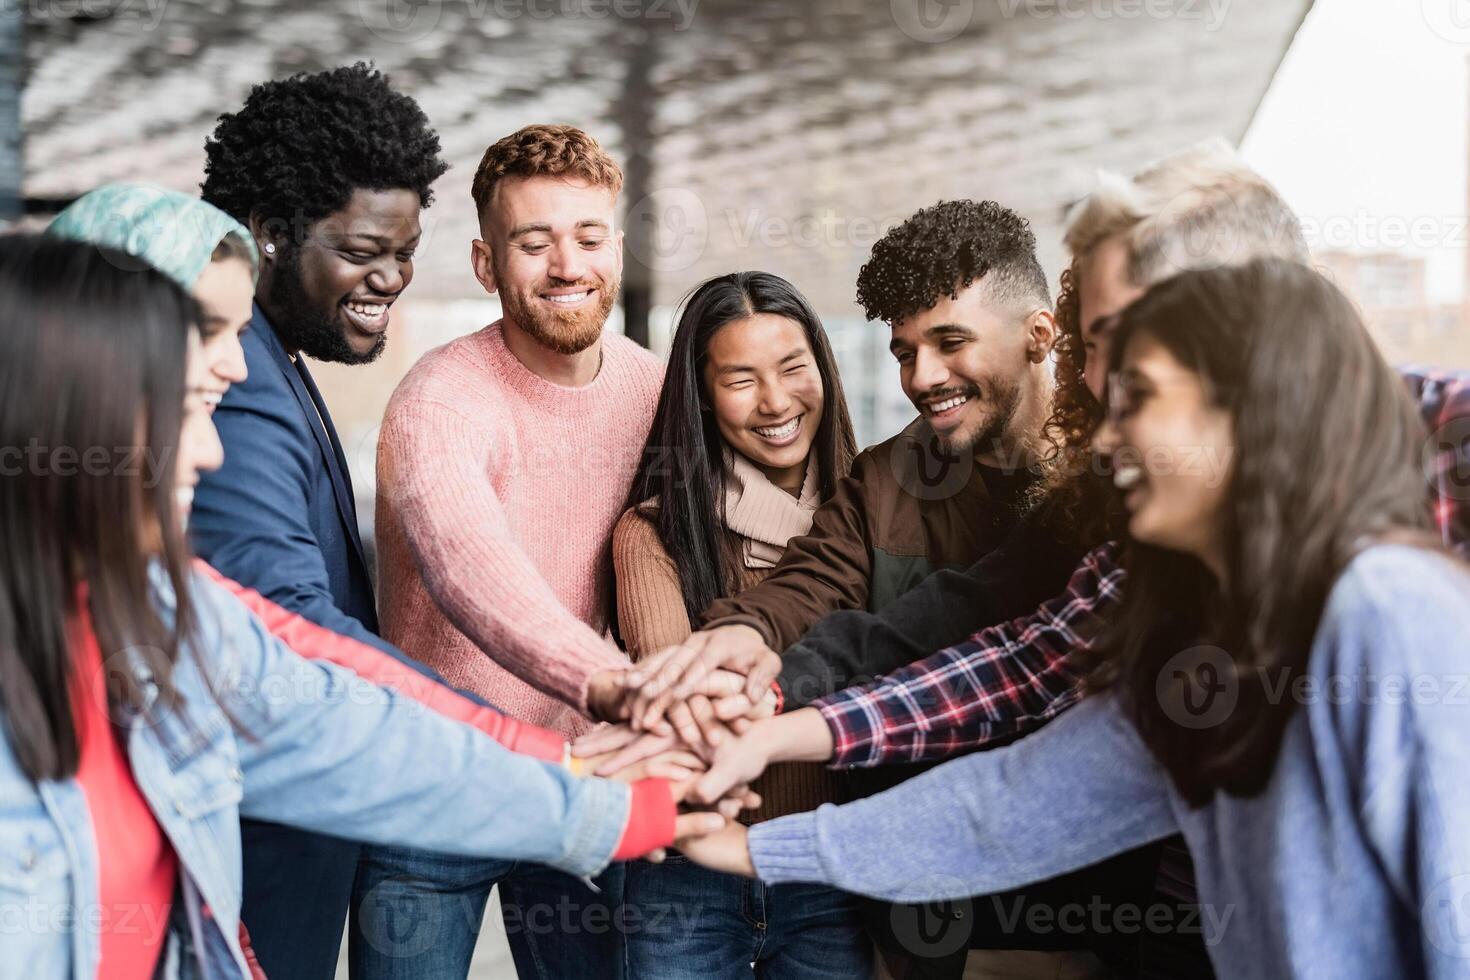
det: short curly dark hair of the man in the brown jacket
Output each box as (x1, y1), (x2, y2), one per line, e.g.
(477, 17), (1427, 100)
(857, 201), (1051, 323)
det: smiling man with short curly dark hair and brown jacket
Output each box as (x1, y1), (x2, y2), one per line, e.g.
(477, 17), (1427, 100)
(614, 200), (1070, 977)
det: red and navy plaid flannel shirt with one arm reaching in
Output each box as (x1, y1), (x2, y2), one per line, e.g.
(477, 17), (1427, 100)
(811, 370), (1470, 768)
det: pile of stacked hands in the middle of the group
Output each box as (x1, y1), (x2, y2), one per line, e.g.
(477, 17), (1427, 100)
(572, 626), (805, 876)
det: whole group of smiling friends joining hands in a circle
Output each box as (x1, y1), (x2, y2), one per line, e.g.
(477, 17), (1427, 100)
(0, 65), (1470, 980)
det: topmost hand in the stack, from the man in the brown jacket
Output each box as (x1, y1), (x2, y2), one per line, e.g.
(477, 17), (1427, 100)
(625, 624), (781, 729)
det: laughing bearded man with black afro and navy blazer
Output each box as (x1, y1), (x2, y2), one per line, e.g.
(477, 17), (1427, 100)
(190, 63), (447, 980)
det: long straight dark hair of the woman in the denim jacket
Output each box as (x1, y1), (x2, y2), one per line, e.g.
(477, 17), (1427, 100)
(0, 235), (198, 780)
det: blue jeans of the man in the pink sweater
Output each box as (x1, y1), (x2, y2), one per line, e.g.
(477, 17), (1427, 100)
(347, 848), (625, 980)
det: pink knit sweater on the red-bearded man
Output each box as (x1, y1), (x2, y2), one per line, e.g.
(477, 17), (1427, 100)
(376, 322), (663, 736)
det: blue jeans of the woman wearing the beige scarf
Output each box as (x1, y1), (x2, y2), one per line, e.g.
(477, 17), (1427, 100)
(626, 851), (873, 980)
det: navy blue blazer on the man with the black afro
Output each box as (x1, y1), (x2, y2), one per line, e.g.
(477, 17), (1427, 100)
(188, 306), (396, 660)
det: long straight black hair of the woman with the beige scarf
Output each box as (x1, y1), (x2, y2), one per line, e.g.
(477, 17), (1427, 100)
(613, 272), (857, 623)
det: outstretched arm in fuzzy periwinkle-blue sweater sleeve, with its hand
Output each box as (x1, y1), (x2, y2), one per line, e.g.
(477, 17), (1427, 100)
(679, 696), (1176, 902)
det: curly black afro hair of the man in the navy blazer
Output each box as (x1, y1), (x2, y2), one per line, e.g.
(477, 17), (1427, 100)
(201, 62), (448, 233)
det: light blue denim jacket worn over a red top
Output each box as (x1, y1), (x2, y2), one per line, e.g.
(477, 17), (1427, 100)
(0, 573), (632, 980)
